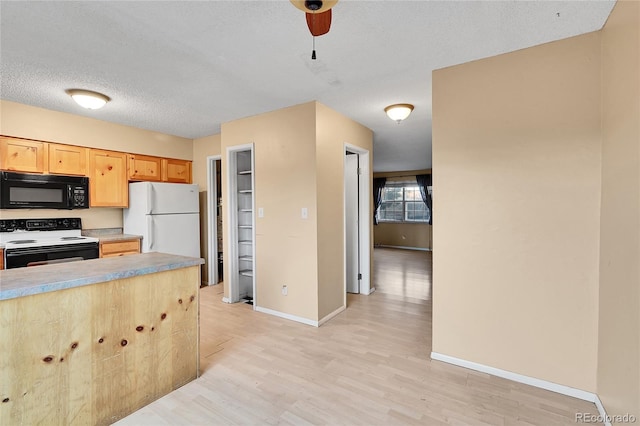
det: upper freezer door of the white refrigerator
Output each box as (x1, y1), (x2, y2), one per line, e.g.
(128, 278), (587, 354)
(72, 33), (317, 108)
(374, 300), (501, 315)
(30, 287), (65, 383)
(147, 183), (200, 214)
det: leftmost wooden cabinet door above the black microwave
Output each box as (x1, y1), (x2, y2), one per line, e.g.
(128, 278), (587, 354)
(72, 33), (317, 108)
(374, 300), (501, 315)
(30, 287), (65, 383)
(0, 137), (49, 173)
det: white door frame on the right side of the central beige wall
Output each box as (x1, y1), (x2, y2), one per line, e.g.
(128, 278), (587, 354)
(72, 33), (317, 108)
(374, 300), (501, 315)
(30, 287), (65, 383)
(342, 142), (375, 300)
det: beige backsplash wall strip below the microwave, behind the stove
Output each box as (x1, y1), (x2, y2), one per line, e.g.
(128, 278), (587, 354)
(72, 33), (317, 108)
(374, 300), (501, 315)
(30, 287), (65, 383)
(0, 207), (122, 229)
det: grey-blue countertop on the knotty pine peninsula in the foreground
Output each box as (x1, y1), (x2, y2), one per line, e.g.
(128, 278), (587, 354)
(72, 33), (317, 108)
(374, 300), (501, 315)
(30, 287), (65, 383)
(0, 253), (204, 300)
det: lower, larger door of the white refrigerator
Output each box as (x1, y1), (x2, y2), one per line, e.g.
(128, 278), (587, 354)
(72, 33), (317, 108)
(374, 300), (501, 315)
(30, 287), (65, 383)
(143, 213), (200, 257)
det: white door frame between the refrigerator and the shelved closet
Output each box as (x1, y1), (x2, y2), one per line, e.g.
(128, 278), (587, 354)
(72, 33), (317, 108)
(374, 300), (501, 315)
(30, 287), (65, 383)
(207, 155), (222, 285)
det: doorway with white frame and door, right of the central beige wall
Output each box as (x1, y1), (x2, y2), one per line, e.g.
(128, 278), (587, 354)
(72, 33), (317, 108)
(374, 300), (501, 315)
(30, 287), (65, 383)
(344, 144), (374, 298)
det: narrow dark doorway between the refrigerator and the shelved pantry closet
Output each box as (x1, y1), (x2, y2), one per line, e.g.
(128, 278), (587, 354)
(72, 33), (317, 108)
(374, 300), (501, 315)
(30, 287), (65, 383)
(206, 155), (224, 285)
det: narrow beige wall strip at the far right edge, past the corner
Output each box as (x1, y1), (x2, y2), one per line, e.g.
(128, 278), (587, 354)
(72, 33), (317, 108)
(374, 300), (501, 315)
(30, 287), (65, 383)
(598, 1), (640, 418)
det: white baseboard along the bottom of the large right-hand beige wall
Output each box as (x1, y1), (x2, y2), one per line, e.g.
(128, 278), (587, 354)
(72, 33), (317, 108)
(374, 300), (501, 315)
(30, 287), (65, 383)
(431, 352), (606, 404)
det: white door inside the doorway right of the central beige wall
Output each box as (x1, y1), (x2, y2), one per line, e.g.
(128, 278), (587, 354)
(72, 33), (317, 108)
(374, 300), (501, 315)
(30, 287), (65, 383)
(344, 154), (360, 293)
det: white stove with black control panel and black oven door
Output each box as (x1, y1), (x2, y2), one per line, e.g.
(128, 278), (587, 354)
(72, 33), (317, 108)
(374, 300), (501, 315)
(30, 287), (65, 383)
(0, 218), (99, 269)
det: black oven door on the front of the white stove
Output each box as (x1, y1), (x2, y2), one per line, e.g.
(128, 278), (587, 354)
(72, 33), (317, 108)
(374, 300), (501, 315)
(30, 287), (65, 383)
(5, 242), (99, 269)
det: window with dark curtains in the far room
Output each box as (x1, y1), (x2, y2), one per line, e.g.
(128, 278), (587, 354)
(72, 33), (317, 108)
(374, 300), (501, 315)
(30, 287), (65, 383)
(378, 182), (431, 222)
